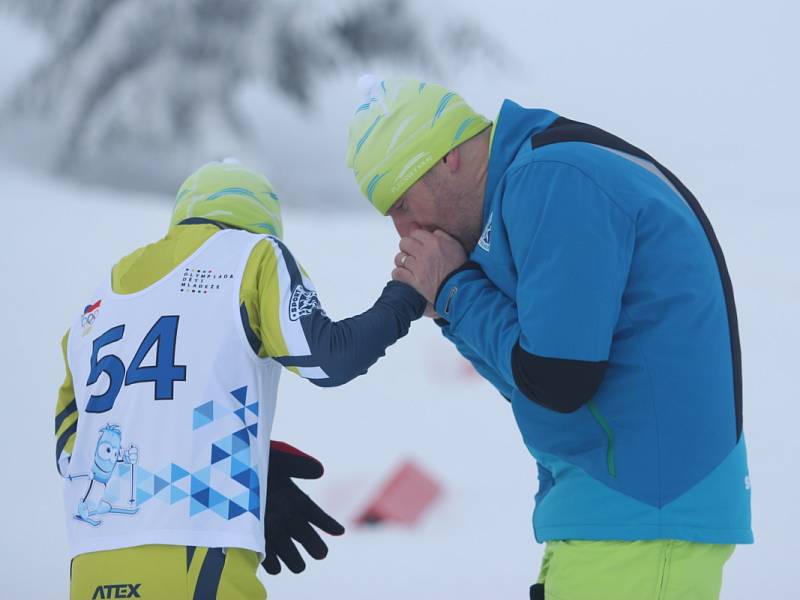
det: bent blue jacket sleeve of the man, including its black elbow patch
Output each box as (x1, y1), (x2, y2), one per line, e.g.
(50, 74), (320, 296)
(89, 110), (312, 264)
(436, 162), (634, 412)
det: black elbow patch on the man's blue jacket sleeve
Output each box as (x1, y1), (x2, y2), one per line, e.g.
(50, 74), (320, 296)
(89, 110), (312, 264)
(511, 342), (608, 413)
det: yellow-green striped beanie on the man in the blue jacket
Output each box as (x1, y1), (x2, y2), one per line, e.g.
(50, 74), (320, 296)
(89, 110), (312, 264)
(347, 75), (491, 214)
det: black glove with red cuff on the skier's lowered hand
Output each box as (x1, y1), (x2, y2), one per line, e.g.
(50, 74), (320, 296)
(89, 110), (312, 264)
(261, 441), (344, 575)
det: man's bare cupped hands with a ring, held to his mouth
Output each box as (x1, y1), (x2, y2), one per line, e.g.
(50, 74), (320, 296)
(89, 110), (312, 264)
(392, 229), (467, 304)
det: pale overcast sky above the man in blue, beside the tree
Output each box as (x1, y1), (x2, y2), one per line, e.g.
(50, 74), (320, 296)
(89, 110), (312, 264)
(0, 0), (800, 216)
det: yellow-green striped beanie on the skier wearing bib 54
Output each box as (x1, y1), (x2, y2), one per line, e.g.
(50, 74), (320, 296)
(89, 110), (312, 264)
(170, 159), (283, 237)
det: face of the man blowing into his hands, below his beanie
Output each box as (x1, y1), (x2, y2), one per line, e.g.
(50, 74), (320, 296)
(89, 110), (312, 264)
(386, 163), (483, 251)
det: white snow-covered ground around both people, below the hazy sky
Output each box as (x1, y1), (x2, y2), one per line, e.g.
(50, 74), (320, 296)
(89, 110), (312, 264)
(0, 156), (800, 600)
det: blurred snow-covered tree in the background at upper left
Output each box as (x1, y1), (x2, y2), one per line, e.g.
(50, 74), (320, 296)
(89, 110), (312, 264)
(0, 0), (496, 198)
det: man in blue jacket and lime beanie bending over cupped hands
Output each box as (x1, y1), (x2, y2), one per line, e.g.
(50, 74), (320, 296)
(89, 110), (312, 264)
(348, 80), (753, 600)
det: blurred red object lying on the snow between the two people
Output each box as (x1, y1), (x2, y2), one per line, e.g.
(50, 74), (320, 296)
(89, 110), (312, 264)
(356, 461), (442, 525)
